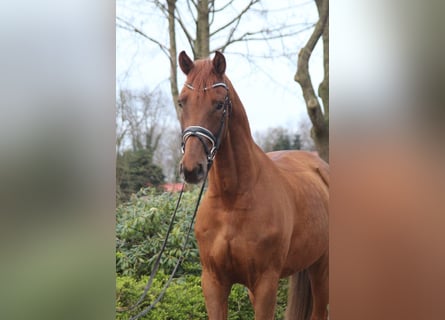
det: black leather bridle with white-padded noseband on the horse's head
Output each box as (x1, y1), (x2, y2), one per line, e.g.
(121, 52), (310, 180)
(181, 82), (232, 168)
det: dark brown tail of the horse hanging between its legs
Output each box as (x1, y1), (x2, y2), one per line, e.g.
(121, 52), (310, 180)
(285, 270), (312, 320)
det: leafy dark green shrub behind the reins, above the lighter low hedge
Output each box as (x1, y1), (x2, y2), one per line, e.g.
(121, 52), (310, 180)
(116, 189), (200, 278)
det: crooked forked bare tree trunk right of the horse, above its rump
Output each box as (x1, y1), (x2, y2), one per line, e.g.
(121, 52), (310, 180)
(295, 0), (329, 162)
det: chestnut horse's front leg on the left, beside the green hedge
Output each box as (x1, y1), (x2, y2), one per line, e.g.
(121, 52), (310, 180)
(201, 270), (231, 320)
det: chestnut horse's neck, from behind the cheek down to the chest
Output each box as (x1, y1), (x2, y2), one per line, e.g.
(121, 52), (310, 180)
(209, 87), (259, 195)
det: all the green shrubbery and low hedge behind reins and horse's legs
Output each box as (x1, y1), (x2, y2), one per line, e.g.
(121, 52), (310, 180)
(116, 188), (287, 320)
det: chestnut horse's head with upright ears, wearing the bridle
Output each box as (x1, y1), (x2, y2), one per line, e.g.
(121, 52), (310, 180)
(178, 51), (231, 183)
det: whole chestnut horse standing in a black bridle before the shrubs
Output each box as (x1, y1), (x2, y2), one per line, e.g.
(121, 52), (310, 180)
(178, 51), (329, 320)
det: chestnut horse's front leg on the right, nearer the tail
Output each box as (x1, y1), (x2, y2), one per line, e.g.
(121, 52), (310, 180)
(250, 274), (279, 320)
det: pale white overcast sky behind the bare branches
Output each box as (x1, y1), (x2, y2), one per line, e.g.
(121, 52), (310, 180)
(116, 0), (323, 133)
